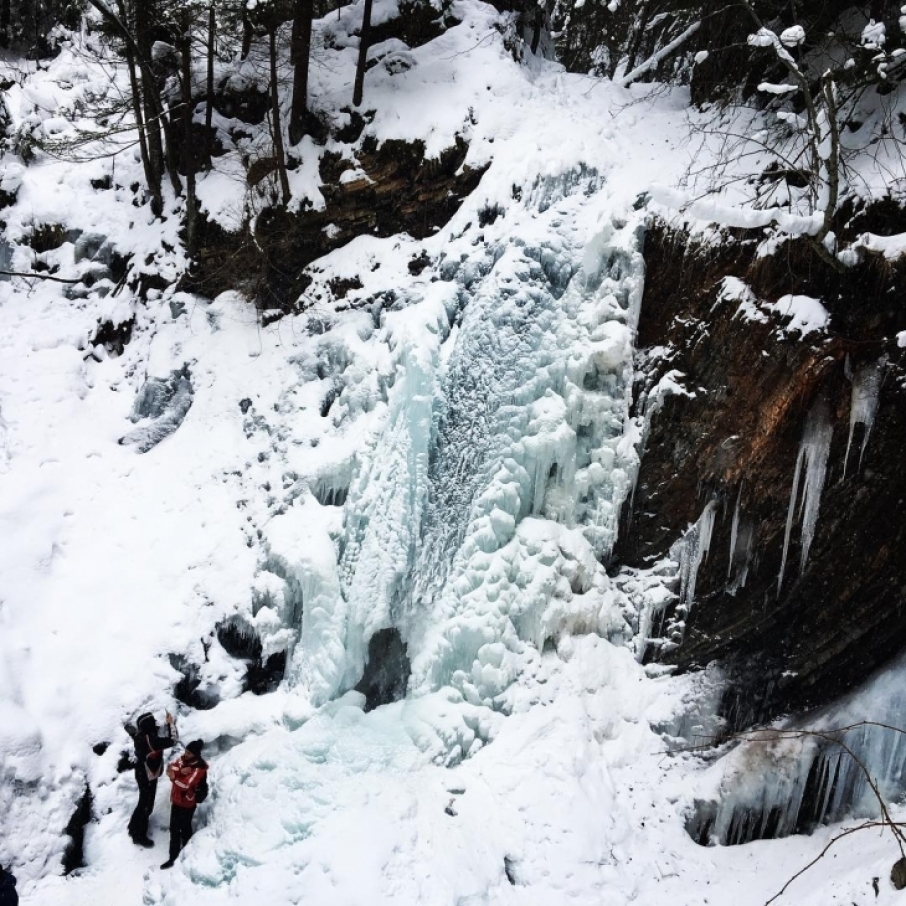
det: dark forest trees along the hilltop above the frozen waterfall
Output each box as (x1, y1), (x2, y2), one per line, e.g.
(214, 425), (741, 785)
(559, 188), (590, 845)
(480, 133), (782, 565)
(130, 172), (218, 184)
(7, 0), (906, 308)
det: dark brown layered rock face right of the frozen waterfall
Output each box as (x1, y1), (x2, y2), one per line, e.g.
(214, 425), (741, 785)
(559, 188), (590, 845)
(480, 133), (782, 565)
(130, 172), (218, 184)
(617, 221), (906, 728)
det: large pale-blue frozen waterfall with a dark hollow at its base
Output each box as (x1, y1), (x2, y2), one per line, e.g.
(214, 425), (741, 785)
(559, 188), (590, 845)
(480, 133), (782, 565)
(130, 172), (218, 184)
(290, 168), (643, 703)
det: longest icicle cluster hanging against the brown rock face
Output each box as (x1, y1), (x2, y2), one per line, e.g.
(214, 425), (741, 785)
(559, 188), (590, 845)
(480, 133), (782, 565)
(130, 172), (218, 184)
(777, 399), (834, 596)
